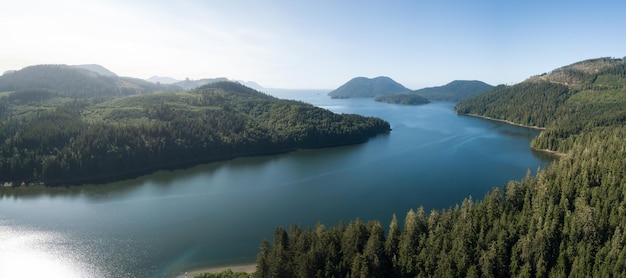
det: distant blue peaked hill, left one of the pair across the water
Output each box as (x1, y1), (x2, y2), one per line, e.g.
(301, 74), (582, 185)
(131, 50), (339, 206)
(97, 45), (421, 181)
(328, 76), (411, 98)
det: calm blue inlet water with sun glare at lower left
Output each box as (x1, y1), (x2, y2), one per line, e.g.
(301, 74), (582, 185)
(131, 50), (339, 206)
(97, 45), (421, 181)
(0, 91), (550, 277)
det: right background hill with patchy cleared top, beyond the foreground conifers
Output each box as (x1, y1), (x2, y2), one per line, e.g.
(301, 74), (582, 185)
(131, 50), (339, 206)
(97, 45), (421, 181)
(456, 58), (626, 153)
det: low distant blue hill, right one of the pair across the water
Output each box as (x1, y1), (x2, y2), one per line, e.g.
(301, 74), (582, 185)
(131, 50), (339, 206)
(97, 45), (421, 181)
(413, 80), (493, 102)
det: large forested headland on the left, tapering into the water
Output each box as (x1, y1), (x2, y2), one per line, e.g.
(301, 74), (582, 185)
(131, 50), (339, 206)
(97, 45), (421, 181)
(0, 65), (390, 186)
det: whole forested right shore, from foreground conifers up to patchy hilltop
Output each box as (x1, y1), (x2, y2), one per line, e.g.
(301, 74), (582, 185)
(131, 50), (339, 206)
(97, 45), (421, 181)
(244, 58), (626, 277)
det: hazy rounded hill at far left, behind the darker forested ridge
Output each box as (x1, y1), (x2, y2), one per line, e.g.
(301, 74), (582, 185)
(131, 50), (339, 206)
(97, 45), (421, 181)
(0, 65), (182, 97)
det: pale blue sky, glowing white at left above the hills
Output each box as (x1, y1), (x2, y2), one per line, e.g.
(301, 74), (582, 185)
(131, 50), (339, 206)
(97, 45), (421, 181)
(0, 0), (626, 89)
